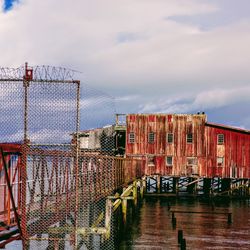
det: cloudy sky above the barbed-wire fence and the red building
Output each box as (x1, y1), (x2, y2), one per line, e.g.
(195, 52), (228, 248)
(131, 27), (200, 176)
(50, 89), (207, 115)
(0, 0), (250, 129)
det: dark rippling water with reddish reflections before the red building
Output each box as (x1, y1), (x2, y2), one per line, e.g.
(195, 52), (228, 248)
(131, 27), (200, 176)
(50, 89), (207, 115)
(119, 198), (250, 250)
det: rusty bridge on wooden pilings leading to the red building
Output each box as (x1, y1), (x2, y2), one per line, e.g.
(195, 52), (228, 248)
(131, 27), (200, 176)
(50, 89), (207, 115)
(0, 144), (145, 248)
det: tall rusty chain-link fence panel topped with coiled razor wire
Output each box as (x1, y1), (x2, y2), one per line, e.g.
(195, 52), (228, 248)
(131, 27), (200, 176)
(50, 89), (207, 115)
(0, 65), (80, 249)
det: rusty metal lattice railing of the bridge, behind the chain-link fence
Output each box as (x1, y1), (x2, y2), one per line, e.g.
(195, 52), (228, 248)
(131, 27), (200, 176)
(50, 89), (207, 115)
(0, 147), (145, 248)
